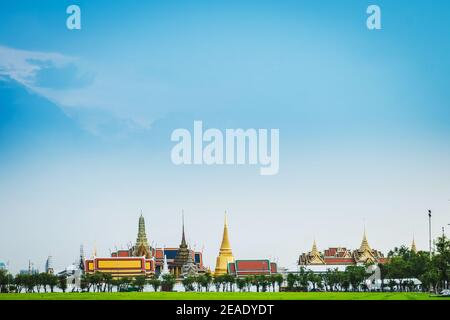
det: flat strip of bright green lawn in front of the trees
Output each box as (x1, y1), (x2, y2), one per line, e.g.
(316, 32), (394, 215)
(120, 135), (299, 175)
(0, 292), (450, 300)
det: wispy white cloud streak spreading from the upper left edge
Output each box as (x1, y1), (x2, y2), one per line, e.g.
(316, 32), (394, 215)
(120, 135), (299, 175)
(0, 46), (165, 136)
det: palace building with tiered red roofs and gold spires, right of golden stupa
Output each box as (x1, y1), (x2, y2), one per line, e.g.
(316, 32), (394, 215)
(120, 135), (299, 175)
(298, 232), (387, 267)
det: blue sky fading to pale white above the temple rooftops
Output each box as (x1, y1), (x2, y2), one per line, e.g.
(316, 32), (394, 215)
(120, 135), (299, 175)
(0, 0), (450, 272)
